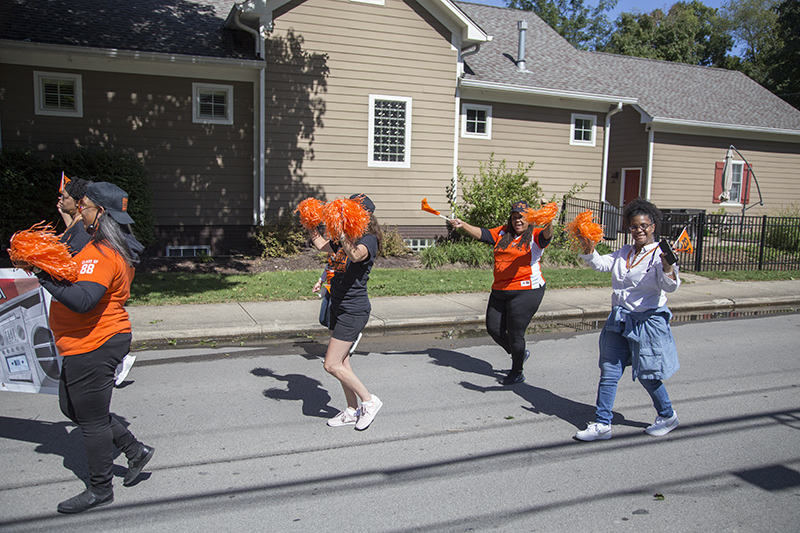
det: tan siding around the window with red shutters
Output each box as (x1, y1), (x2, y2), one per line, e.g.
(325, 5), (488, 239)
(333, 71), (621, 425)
(651, 133), (800, 215)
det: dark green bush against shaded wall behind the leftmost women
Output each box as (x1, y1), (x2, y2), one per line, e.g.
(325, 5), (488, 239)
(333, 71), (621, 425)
(0, 148), (155, 248)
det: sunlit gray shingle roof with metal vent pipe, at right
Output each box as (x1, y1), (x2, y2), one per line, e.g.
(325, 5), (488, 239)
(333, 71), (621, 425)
(456, 2), (800, 132)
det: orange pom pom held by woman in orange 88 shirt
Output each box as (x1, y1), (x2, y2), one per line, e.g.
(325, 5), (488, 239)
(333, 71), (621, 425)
(8, 222), (78, 283)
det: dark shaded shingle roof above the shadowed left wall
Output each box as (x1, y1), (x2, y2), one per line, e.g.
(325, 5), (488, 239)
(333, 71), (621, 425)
(0, 0), (255, 59)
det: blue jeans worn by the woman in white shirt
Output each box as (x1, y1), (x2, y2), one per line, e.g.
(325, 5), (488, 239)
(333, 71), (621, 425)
(596, 328), (674, 424)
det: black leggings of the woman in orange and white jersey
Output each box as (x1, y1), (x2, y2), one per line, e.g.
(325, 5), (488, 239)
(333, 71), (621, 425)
(486, 285), (544, 372)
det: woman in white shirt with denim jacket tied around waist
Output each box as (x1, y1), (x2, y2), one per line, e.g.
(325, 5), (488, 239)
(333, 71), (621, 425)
(575, 198), (681, 441)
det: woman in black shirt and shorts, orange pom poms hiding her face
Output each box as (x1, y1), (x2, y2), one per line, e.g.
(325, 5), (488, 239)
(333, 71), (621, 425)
(309, 194), (383, 431)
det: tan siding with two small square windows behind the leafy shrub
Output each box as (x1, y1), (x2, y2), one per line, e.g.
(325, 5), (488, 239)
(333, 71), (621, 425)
(458, 99), (605, 199)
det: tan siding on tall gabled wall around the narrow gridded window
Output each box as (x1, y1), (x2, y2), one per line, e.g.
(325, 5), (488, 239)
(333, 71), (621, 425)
(266, 0), (457, 224)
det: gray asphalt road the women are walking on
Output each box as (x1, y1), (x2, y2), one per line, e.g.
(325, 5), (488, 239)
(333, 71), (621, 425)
(0, 314), (800, 532)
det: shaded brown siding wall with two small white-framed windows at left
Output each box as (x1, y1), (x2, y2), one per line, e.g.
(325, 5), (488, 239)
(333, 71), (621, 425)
(0, 65), (253, 233)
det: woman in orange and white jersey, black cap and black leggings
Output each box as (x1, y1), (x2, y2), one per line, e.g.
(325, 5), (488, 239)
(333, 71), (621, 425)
(451, 200), (553, 385)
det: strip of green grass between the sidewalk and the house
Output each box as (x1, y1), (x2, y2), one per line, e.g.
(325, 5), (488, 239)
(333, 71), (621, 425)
(127, 268), (611, 305)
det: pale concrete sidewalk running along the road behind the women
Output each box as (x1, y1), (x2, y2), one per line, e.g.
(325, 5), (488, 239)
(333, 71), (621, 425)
(128, 274), (800, 343)
